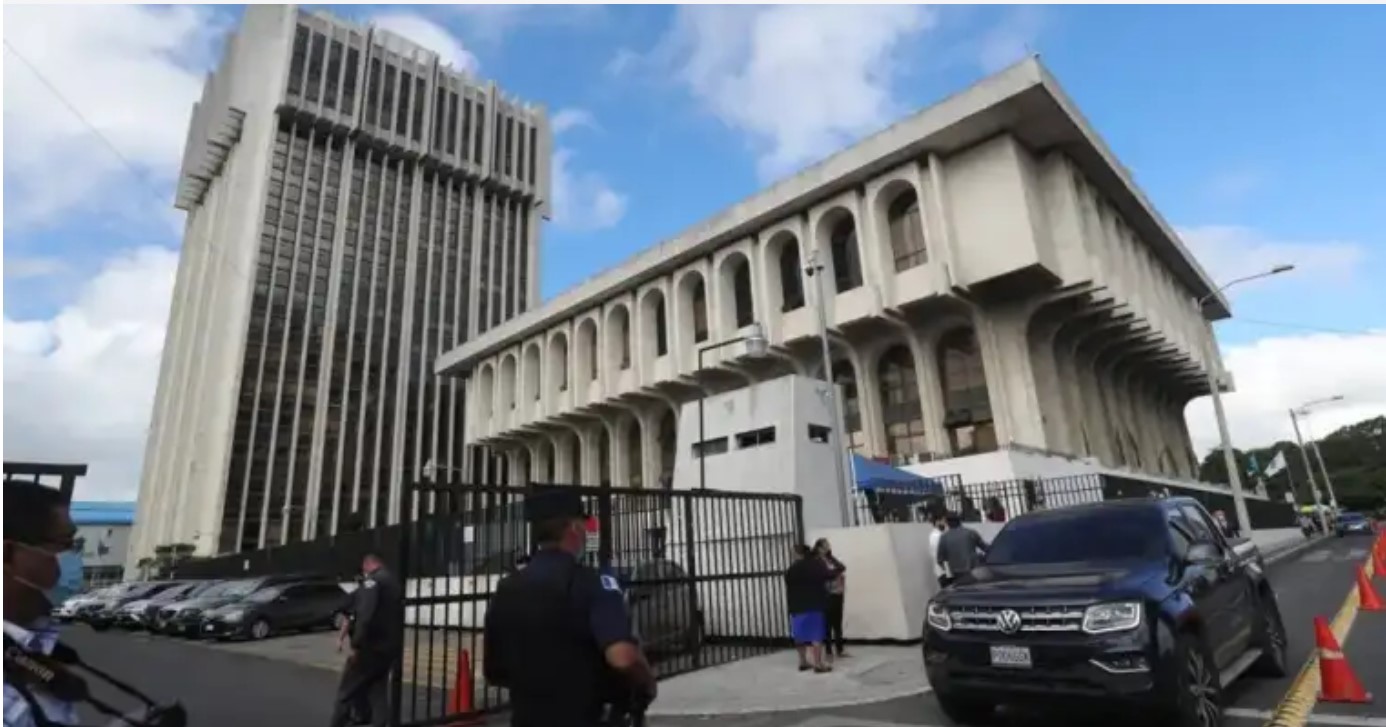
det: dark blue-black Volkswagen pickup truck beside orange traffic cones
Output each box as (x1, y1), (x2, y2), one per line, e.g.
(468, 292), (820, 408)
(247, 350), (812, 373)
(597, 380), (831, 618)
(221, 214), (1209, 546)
(923, 497), (1286, 727)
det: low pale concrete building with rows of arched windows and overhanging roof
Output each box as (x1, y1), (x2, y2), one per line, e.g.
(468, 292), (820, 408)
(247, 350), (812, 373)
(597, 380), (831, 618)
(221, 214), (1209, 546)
(437, 60), (1229, 489)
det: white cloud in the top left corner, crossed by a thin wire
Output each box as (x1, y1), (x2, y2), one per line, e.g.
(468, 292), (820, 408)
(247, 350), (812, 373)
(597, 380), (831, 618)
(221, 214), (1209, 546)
(4, 4), (225, 231)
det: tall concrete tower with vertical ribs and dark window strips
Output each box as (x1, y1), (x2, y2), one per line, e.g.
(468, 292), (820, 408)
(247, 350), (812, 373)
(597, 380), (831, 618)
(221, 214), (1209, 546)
(129, 6), (552, 566)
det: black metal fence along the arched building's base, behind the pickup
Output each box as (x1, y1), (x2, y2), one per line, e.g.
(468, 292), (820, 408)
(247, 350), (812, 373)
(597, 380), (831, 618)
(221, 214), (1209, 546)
(855, 475), (1297, 532)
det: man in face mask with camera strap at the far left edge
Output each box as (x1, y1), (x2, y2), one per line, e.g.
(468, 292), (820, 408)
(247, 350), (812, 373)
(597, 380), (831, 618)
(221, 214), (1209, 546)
(4, 482), (82, 727)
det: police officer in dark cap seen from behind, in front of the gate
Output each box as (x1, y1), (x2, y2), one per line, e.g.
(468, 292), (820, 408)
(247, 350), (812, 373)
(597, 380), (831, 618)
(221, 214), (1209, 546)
(482, 489), (656, 727)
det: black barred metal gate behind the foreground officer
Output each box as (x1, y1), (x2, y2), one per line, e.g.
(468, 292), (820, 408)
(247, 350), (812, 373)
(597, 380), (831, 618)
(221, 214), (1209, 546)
(391, 483), (804, 727)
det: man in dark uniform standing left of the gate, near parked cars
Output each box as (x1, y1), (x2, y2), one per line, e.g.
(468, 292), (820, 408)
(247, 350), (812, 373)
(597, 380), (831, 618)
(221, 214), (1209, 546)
(331, 553), (405, 727)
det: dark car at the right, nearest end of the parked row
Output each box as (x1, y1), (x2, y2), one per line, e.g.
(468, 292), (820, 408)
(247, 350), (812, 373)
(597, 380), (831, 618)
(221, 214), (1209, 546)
(202, 580), (347, 640)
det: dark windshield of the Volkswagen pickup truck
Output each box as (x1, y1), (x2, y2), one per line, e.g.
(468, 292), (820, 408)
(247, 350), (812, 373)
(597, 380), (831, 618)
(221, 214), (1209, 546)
(985, 507), (1168, 565)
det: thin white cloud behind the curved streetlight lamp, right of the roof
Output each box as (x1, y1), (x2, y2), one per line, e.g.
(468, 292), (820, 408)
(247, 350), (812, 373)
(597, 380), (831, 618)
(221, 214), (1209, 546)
(1178, 224), (1368, 285)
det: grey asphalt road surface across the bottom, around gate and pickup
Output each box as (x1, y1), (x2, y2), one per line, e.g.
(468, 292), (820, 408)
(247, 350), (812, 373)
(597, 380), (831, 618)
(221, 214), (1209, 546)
(54, 539), (1386, 727)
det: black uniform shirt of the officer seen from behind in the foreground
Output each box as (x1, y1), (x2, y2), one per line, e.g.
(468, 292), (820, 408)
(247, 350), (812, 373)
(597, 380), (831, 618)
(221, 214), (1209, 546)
(482, 550), (636, 727)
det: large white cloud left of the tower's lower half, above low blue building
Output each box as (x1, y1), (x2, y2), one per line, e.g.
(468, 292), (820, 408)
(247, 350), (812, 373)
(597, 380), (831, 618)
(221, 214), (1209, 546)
(4, 246), (177, 500)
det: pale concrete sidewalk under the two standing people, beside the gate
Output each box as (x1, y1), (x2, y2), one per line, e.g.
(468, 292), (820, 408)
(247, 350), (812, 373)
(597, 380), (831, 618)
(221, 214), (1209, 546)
(650, 645), (929, 716)
